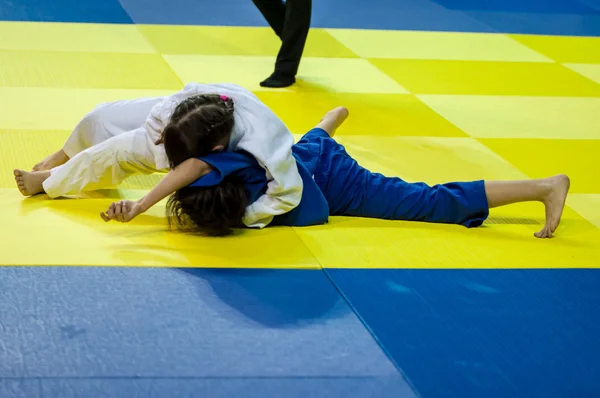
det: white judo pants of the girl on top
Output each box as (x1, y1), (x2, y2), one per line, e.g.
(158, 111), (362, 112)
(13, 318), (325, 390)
(43, 97), (169, 198)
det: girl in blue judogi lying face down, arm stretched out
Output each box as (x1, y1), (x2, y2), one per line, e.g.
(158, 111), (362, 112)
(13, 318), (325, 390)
(102, 108), (570, 238)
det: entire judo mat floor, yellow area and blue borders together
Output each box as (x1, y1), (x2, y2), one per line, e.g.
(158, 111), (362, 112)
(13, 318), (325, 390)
(0, 0), (600, 398)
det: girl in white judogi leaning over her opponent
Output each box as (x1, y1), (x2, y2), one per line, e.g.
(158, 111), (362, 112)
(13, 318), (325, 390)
(14, 83), (302, 228)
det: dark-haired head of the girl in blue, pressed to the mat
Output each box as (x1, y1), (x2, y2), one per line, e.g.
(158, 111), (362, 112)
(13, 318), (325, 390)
(167, 176), (248, 236)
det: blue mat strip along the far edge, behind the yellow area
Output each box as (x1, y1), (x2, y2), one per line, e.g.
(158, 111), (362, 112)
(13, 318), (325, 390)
(0, 0), (600, 36)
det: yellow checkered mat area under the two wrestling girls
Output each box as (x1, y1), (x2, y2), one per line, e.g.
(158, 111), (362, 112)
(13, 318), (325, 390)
(0, 22), (600, 268)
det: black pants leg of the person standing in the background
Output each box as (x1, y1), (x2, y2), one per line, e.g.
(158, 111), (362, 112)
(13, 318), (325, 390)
(252, 0), (312, 76)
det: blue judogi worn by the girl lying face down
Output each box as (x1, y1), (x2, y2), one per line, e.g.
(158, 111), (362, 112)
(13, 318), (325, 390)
(190, 128), (489, 227)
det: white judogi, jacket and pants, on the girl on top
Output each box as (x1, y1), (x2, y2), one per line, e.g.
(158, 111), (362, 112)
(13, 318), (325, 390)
(43, 83), (302, 228)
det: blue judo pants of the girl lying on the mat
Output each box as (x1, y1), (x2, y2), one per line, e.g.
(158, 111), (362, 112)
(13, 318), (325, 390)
(297, 129), (489, 227)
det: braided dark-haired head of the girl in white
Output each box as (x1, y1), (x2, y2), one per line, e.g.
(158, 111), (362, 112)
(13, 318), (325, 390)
(162, 94), (233, 168)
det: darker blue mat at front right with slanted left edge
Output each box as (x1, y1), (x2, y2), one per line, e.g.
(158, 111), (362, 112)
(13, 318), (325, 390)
(327, 269), (600, 398)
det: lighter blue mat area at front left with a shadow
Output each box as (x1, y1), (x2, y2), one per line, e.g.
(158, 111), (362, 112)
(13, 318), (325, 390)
(0, 267), (415, 398)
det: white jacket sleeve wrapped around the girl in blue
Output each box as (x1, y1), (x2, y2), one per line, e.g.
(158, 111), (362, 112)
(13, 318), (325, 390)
(238, 113), (303, 228)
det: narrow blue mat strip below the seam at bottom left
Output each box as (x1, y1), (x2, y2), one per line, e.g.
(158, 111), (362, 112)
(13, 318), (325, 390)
(0, 377), (416, 398)
